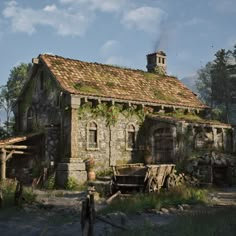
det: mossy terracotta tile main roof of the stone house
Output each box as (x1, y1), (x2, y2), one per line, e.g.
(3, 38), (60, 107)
(39, 54), (206, 108)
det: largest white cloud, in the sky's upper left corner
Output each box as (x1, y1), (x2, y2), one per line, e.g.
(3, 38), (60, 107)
(3, 1), (92, 36)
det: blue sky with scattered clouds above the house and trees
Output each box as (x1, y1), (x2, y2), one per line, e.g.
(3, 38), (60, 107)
(0, 0), (236, 85)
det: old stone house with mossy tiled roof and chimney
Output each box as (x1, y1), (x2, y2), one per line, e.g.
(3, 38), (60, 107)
(11, 52), (236, 185)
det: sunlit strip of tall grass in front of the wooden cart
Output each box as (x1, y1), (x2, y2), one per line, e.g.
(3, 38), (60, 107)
(100, 186), (208, 214)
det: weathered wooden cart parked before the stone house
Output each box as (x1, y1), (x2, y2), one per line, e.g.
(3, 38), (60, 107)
(111, 163), (175, 193)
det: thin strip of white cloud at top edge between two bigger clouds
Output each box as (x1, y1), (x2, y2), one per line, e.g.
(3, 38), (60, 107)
(60, 0), (128, 12)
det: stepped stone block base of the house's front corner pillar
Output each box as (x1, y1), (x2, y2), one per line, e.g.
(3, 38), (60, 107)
(56, 158), (87, 187)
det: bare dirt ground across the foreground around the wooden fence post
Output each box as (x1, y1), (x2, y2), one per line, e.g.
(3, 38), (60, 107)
(0, 188), (236, 236)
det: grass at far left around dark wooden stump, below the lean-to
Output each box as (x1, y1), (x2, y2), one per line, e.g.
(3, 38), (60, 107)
(0, 180), (36, 208)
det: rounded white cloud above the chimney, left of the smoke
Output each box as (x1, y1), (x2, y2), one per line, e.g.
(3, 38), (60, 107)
(122, 7), (167, 33)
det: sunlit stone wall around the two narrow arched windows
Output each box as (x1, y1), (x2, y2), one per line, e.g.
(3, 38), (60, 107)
(77, 109), (143, 171)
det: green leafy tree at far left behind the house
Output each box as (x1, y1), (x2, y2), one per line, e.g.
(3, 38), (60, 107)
(0, 63), (31, 133)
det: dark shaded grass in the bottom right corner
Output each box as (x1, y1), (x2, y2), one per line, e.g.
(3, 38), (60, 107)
(112, 206), (236, 236)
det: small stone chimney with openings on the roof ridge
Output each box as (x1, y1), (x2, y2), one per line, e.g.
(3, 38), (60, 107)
(147, 51), (166, 74)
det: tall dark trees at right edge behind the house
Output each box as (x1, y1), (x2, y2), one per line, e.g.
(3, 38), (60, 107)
(196, 45), (236, 123)
